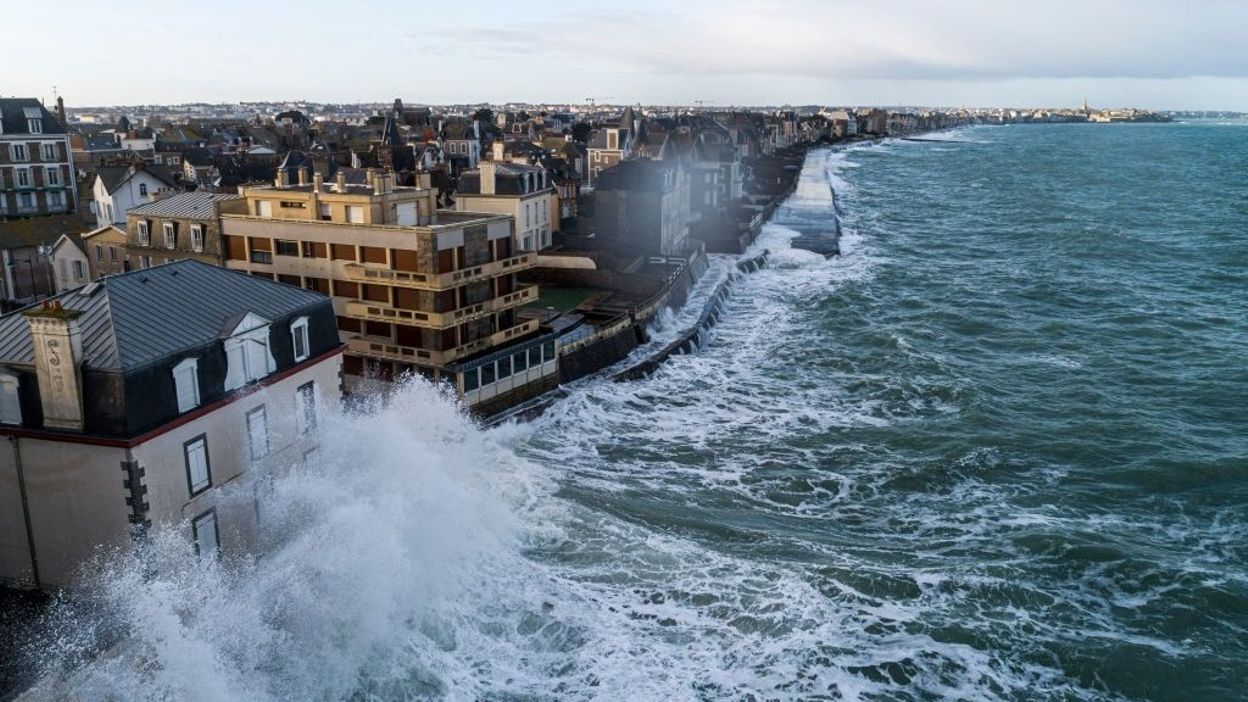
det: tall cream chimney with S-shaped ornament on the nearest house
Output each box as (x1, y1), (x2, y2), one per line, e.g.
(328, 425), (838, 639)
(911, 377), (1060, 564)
(22, 300), (84, 431)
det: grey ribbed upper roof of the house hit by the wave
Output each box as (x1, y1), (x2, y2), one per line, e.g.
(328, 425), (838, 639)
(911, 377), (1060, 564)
(0, 259), (327, 371)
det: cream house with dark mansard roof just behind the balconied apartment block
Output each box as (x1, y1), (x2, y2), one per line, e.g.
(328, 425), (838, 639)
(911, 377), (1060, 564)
(456, 161), (559, 251)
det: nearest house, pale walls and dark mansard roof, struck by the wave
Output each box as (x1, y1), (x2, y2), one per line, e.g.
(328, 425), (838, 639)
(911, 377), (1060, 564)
(0, 261), (342, 590)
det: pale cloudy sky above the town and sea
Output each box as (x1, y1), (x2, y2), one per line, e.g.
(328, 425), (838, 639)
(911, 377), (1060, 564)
(9, 0), (1248, 111)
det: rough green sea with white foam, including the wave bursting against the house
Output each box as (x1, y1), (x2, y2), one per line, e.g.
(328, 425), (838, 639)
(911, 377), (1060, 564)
(19, 121), (1248, 702)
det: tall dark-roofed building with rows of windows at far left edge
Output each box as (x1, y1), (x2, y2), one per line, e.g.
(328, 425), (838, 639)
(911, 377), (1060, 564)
(0, 97), (77, 221)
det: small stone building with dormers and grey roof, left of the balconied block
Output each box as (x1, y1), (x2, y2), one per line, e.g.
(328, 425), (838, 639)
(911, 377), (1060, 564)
(126, 191), (247, 269)
